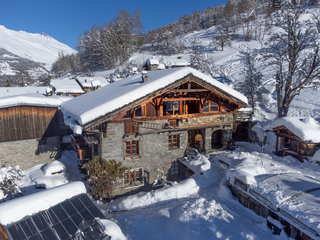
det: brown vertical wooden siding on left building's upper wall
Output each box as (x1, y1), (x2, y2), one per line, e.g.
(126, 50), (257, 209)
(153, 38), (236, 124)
(0, 106), (59, 142)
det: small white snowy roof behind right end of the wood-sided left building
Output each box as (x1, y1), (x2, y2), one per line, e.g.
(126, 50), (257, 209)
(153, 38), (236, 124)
(50, 78), (85, 94)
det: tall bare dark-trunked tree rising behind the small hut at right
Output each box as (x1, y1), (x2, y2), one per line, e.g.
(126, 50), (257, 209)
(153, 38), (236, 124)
(264, 1), (320, 117)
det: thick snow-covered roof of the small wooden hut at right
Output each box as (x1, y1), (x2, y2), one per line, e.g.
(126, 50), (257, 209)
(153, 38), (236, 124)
(264, 117), (320, 143)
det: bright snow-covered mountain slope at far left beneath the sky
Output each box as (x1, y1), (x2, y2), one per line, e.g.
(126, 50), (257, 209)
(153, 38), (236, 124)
(0, 25), (76, 83)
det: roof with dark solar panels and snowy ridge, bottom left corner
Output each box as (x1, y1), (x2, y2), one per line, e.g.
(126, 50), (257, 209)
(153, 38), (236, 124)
(0, 182), (115, 240)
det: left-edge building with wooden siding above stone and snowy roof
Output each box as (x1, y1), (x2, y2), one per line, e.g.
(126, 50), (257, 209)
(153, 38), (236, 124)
(0, 93), (70, 170)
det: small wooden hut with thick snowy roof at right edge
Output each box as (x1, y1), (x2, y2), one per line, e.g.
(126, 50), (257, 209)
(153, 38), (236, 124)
(265, 117), (320, 162)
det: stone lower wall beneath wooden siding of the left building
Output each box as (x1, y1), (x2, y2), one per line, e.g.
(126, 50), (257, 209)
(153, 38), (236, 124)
(0, 137), (61, 170)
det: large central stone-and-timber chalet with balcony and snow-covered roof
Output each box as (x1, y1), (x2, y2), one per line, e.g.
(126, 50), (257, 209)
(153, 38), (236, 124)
(61, 67), (247, 195)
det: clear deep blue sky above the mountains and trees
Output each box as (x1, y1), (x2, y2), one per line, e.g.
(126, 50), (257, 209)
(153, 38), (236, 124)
(0, 0), (227, 48)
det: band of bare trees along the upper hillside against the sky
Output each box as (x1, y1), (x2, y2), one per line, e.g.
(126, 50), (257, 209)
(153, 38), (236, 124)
(51, 0), (317, 77)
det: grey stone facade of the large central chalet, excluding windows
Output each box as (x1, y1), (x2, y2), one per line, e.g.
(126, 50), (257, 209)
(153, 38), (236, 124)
(101, 114), (233, 193)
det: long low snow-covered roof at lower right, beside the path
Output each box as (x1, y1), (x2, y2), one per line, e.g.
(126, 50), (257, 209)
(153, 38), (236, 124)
(225, 152), (320, 234)
